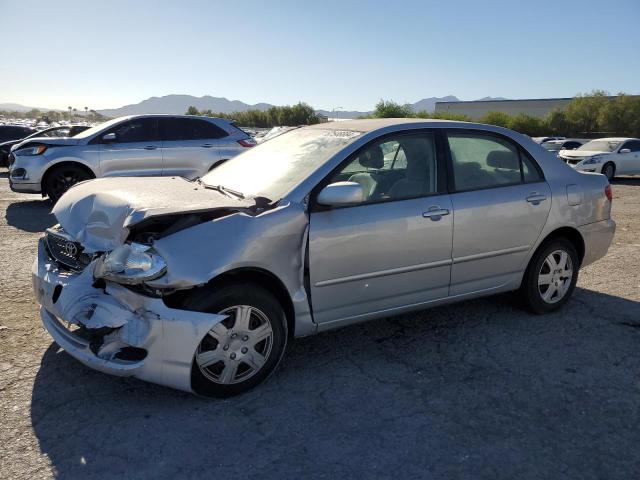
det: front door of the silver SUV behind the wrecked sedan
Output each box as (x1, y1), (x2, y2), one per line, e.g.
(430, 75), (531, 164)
(97, 117), (162, 177)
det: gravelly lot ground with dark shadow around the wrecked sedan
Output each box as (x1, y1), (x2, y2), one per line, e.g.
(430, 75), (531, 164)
(0, 172), (640, 479)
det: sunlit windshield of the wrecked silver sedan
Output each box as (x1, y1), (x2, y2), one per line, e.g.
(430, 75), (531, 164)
(202, 128), (360, 201)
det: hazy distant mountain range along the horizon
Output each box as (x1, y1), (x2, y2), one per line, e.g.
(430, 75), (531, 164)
(0, 95), (504, 118)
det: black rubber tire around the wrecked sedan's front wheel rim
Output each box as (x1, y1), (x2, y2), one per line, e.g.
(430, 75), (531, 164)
(185, 283), (287, 397)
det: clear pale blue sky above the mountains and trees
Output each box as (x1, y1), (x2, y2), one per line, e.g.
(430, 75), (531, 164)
(0, 0), (640, 110)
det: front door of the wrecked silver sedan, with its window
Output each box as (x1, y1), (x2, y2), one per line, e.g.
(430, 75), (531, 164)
(308, 131), (453, 324)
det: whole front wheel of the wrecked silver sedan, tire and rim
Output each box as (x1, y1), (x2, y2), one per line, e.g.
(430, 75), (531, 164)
(186, 283), (287, 397)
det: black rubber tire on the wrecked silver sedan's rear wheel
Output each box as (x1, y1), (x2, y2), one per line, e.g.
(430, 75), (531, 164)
(520, 238), (580, 314)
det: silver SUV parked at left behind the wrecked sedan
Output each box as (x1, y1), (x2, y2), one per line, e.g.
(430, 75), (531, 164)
(9, 115), (255, 202)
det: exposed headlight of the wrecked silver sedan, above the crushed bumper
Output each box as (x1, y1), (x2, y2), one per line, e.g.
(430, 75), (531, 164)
(93, 243), (167, 285)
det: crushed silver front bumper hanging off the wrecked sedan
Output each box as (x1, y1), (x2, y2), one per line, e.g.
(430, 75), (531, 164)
(32, 239), (226, 392)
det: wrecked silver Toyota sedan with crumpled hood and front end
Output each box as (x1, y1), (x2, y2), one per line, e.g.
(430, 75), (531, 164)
(34, 119), (615, 396)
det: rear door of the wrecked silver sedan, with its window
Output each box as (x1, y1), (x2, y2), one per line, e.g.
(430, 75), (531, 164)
(447, 130), (551, 296)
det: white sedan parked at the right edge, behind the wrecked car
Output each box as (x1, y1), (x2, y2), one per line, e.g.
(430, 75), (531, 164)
(559, 138), (640, 180)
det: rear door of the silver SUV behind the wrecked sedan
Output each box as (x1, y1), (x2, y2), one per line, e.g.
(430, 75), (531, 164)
(161, 117), (228, 178)
